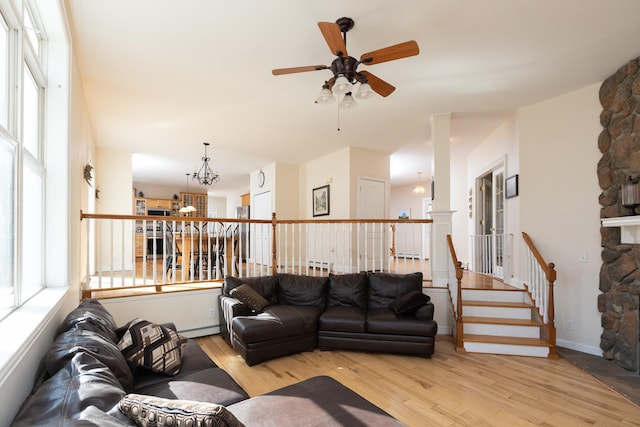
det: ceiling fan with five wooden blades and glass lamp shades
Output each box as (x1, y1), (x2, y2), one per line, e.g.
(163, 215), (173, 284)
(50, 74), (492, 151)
(271, 17), (420, 108)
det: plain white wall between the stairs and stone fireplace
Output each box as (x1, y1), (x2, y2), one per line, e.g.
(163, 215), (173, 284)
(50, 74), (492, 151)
(517, 84), (602, 354)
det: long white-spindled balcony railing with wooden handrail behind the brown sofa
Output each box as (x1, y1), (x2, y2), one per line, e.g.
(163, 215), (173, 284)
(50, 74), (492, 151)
(81, 214), (432, 289)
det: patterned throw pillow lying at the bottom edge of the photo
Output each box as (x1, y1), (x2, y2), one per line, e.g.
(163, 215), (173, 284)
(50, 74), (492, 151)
(118, 394), (244, 427)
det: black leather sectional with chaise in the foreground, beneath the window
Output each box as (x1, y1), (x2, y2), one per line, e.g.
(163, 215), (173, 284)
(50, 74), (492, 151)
(12, 300), (404, 427)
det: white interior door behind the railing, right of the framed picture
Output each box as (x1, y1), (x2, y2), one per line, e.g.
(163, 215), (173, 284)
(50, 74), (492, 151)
(357, 177), (389, 271)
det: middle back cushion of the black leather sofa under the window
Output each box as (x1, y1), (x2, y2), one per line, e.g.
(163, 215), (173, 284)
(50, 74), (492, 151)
(44, 329), (133, 390)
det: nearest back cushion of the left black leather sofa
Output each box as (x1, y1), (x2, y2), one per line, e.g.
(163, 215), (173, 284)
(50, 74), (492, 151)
(12, 352), (131, 427)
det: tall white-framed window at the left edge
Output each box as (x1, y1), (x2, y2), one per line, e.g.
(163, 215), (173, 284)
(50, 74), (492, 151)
(0, 0), (47, 319)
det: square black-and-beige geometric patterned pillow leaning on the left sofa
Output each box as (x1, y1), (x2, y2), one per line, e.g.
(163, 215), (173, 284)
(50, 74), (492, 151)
(118, 319), (187, 375)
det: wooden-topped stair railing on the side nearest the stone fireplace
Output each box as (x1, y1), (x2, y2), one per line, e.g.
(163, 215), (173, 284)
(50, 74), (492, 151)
(522, 231), (557, 357)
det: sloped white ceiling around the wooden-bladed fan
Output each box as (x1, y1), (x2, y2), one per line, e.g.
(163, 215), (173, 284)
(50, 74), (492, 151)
(66, 0), (640, 195)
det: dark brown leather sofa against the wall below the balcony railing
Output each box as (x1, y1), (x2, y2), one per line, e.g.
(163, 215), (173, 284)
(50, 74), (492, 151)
(219, 272), (438, 365)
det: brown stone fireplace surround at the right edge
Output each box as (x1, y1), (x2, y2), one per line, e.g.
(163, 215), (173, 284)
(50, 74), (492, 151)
(597, 58), (640, 371)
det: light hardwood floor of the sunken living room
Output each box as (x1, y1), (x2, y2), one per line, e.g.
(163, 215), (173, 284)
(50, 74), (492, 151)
(197, 335), (640, 427)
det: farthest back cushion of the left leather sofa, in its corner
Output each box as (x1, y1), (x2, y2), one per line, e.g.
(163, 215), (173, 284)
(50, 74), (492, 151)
(56, 299), (118, 344)
